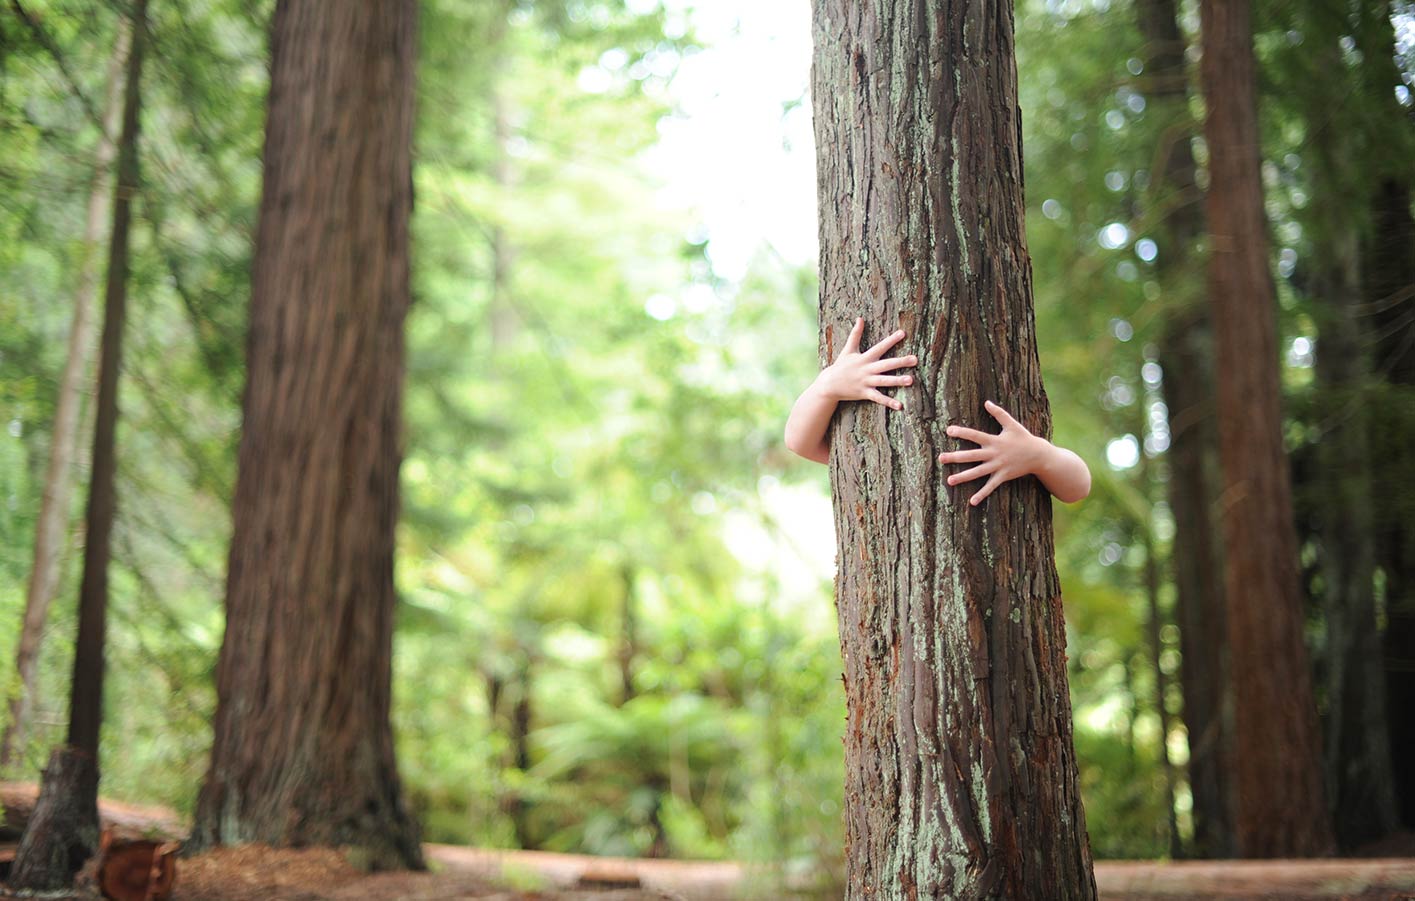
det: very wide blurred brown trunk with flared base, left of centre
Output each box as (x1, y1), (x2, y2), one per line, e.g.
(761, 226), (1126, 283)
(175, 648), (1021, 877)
(188, 0), (425, 868)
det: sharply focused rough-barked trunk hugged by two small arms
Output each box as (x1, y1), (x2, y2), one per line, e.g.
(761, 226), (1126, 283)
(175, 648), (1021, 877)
(812, 0), (1095, 898)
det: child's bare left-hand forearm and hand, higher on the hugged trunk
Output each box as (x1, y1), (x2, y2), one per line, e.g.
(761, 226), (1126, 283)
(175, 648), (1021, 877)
(785, 318), (918, 463)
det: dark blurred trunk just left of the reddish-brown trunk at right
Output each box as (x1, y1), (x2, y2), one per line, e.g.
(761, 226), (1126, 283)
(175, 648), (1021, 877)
(1136, 0), (1232, 857)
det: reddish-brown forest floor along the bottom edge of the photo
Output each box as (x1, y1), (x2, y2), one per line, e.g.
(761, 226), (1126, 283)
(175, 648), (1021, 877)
(0, 782), (1415, 901)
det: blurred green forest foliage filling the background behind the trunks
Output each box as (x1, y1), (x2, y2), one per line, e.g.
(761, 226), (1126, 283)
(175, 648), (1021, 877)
(0, 0), (1415, 888)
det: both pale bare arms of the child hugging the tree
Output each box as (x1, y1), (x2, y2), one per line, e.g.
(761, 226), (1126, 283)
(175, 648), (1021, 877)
(785, 318), (1091, 506)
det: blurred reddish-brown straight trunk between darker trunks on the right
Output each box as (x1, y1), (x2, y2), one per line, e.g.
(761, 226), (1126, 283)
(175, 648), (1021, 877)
(1200, 0), (1333, 857)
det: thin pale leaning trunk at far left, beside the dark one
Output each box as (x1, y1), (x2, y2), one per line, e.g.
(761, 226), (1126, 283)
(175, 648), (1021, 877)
(0, 20), (129, 769)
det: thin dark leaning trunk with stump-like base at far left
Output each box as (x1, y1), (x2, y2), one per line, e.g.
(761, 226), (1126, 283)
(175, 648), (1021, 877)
(8, 0), (147, 890)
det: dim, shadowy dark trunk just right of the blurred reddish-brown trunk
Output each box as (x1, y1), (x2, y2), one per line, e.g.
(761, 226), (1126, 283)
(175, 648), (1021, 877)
(1305, 15), (1398, 850)
